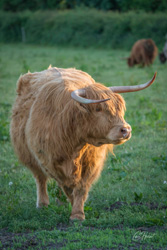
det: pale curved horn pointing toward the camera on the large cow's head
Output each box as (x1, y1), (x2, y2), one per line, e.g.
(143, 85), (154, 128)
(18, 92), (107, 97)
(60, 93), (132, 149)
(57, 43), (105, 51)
(71, 89), (110, 104)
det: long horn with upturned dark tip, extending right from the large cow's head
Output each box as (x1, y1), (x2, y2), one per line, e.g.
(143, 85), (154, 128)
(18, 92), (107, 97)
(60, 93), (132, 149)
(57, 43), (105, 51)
(109, 72), (157, 93)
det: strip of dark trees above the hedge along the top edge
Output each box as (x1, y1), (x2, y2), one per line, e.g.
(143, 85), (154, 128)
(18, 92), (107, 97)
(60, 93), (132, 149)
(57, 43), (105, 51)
(0, 0), (167, 12)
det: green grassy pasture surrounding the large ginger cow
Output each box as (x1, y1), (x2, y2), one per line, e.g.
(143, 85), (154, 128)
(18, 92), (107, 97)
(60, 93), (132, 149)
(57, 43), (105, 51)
(0, 44), (167, 250)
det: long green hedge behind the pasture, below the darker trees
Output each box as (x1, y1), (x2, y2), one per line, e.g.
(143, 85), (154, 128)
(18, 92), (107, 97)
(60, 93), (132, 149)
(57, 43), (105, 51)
(0, 9), (167, 49)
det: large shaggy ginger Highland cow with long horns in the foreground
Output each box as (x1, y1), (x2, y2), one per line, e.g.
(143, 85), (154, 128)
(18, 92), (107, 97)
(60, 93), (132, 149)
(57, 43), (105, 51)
(10, 68), (155, 220)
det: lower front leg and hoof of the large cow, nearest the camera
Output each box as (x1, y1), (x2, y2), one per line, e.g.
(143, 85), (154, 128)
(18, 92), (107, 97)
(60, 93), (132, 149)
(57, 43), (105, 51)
(70, 185), (89, 220)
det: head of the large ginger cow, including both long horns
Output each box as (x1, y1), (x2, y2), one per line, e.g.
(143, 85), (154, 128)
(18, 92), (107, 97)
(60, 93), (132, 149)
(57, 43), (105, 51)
(71, 73), (156, 146)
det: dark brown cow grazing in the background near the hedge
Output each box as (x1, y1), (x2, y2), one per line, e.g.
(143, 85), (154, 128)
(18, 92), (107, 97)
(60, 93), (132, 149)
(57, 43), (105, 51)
(127, 39), (158, 67)
